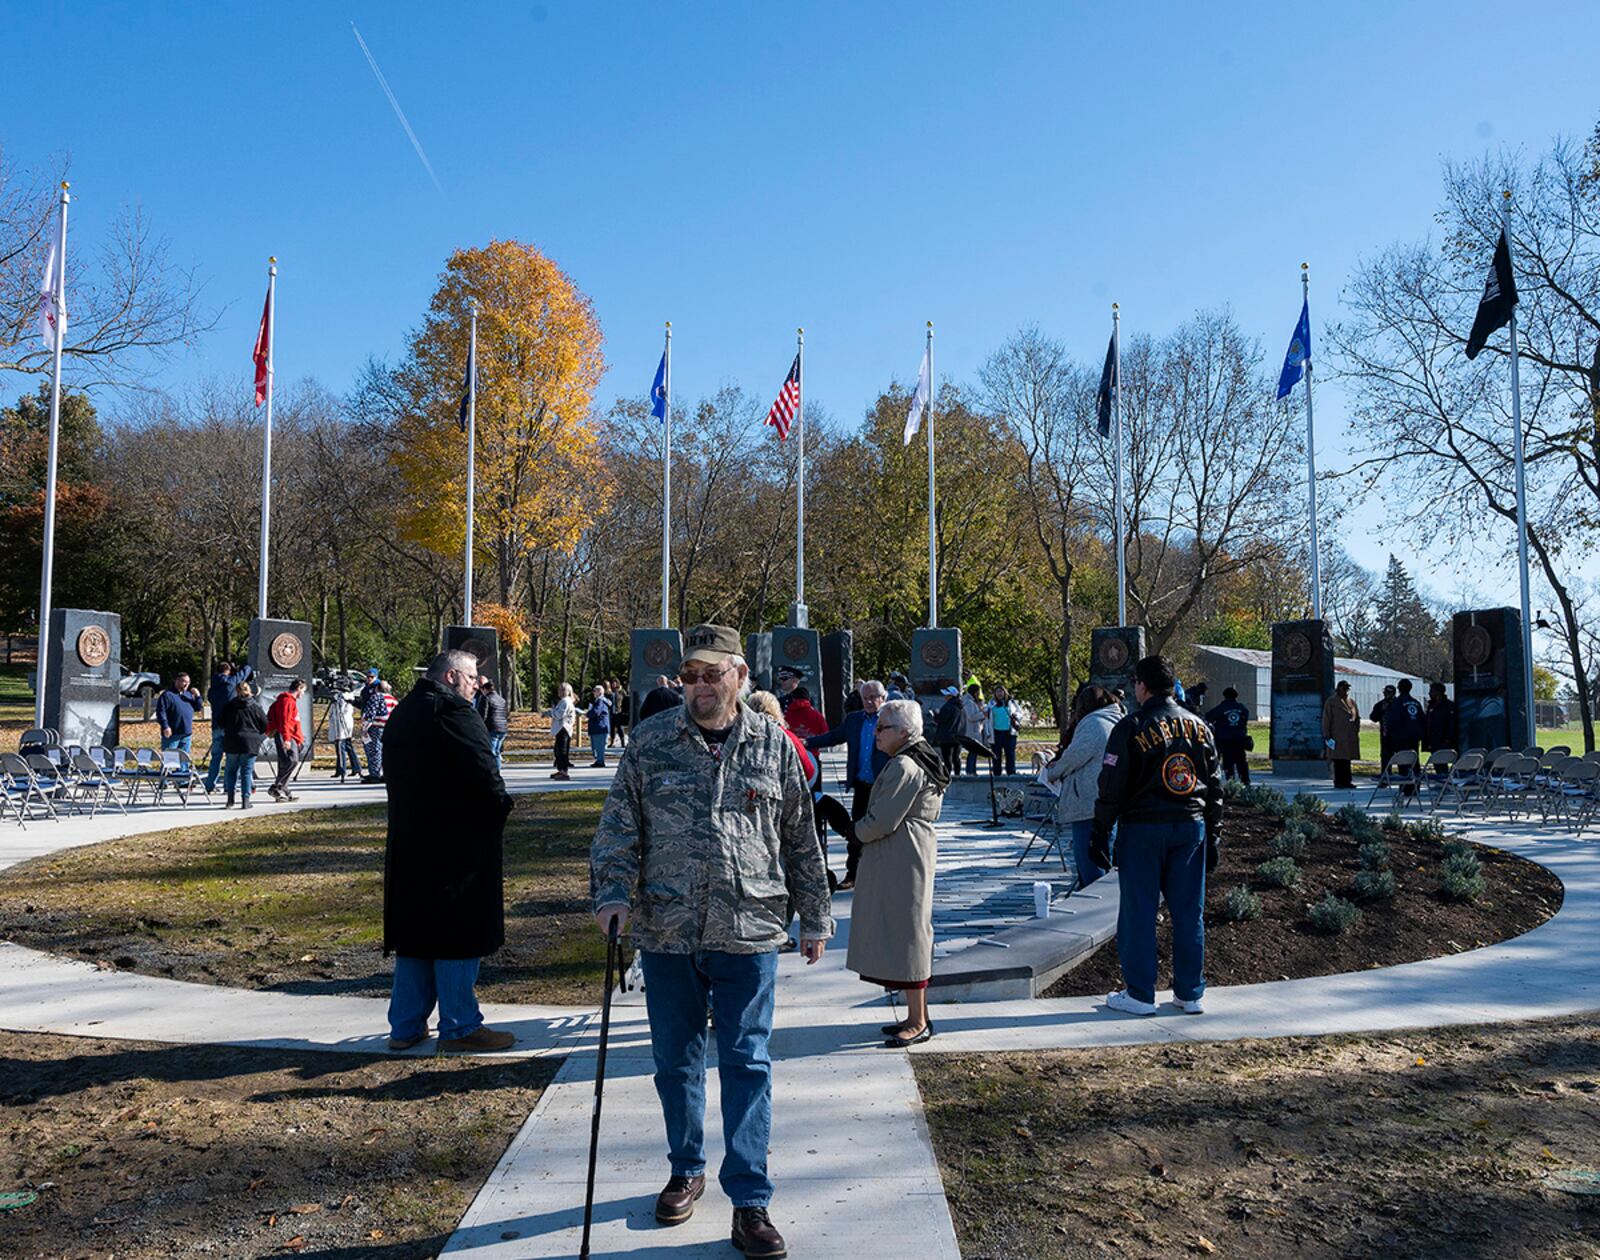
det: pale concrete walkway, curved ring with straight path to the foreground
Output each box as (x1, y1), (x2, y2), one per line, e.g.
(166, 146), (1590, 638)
(0, 769), (1600, 1260)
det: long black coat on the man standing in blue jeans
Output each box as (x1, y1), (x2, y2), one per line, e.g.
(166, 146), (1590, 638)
(384, 678), (510, 958)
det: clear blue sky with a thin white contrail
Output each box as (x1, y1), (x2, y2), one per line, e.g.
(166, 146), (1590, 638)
(0, 0), (1600, 595)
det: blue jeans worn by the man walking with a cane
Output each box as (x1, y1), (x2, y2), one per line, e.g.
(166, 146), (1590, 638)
(640, 950), (778, 1207)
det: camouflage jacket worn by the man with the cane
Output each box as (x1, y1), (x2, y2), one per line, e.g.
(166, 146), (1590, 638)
(589, 705), (834, 953)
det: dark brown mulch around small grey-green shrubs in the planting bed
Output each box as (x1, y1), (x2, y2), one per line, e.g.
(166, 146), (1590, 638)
(1045, 804), (1563, 998)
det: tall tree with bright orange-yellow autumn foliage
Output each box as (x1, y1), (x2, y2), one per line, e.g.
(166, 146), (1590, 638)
(390, 240), (605, 606)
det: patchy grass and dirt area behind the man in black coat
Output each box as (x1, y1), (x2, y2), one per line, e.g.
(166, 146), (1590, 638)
(0, 791), (605, 1004)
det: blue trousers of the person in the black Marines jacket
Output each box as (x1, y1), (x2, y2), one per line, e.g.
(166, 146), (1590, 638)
(1117, 819), (1205, 1003)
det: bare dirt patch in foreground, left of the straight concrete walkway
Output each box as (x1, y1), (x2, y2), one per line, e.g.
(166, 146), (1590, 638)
(0, 1033), (558, 1260)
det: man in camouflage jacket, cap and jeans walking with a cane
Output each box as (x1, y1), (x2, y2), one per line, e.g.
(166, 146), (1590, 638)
(590, 625), (834, 1257)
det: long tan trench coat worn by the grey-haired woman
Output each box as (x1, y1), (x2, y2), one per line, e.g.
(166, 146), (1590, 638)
(845, 756), (944, 980)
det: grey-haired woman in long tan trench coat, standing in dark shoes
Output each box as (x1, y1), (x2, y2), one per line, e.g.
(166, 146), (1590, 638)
(845, 700), (950, 1047)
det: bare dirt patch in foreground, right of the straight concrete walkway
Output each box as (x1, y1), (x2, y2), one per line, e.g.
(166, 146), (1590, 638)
(912, 1015), (1600, 1260)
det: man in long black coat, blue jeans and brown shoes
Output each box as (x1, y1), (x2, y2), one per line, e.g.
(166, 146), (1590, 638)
(384, 651), (517, 1051)
